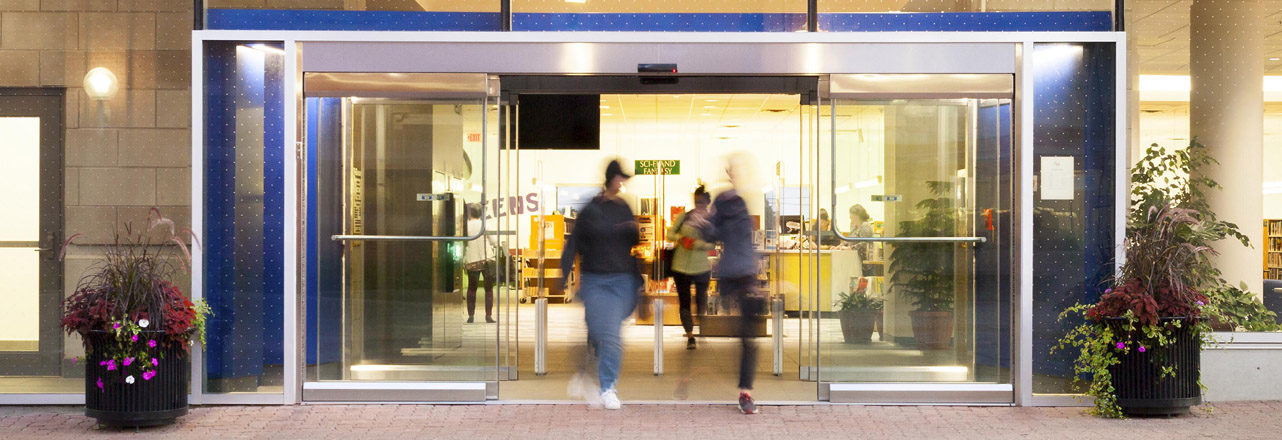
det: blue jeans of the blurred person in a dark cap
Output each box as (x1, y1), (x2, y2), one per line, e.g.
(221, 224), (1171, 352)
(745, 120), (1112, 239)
(577, 272), (640, 391)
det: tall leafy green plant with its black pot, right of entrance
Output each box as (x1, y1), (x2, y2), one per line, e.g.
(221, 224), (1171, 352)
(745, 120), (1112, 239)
(1055, 139), (1249, 417)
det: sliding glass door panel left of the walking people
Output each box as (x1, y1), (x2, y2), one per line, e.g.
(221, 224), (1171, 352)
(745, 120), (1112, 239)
(313, 91), (503, 381)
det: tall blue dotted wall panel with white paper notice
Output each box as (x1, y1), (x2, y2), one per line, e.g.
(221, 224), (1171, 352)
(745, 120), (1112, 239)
(1033, 44), (1118, 393)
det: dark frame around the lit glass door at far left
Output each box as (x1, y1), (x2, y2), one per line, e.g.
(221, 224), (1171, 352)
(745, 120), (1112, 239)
(0, 89), (72, 376)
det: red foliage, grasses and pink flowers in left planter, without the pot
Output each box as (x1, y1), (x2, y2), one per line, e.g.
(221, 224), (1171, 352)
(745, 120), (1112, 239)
(62, 208), (209, 391)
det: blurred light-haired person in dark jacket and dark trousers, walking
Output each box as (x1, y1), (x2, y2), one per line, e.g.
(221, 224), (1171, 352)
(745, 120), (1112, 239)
(687, 155), (765, 414)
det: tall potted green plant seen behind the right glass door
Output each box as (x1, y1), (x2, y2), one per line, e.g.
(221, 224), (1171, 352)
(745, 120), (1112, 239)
(888, 181), (956, 350)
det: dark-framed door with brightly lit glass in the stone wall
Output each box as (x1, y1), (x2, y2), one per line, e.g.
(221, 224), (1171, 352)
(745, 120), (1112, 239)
(0, 89), (64, 387)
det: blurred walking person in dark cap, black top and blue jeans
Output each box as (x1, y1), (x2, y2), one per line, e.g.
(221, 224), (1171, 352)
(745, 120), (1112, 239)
(562, 160), (641, 409)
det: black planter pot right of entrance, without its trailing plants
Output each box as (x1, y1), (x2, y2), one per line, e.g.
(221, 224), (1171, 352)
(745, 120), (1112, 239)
(1109, 318), (1201, 416)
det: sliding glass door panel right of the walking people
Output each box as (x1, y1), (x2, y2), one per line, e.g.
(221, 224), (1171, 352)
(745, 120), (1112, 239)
(818, 97), (1011, 384)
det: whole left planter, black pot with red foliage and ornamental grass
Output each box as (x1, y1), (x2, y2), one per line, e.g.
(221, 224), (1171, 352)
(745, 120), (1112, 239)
(62, 209), (209, 426)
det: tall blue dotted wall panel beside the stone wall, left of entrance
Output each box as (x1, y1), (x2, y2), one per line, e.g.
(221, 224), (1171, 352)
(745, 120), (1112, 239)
(203, 44), (285, 393)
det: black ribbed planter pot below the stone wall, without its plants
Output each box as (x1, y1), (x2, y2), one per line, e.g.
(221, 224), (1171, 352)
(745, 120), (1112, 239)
(85, 331), (188, 426)
